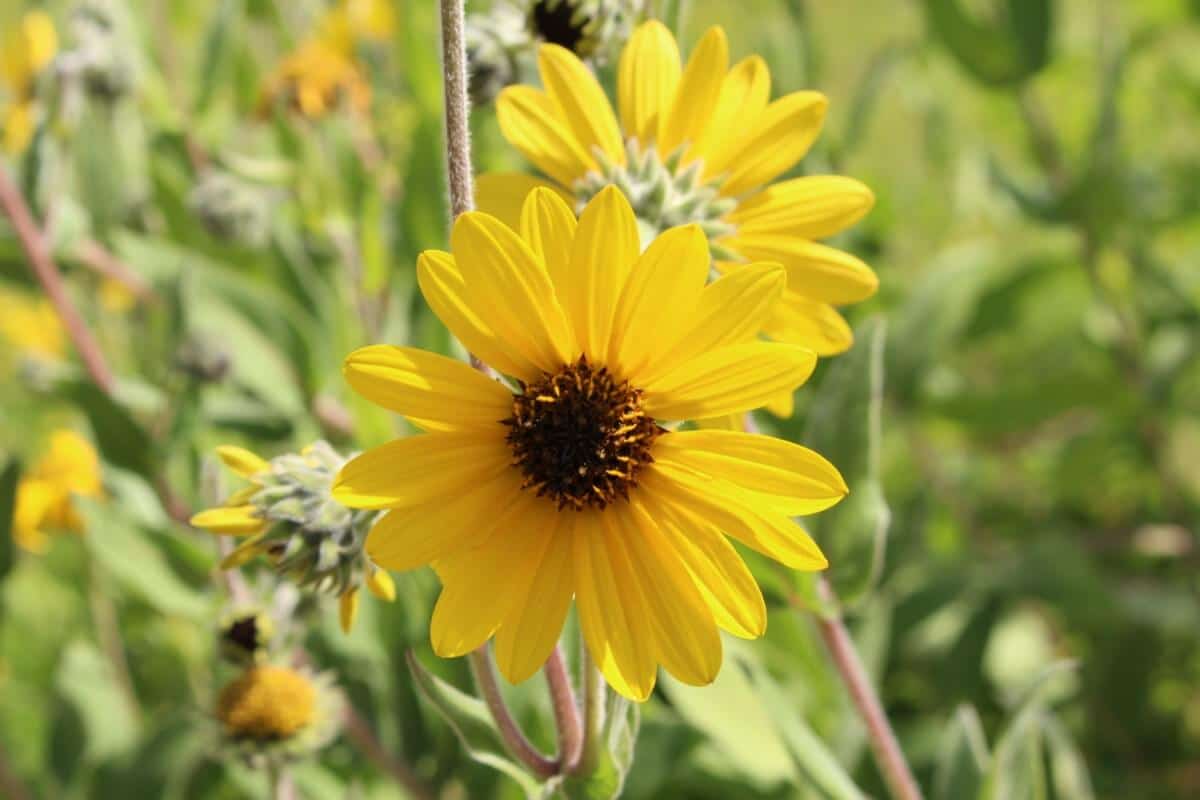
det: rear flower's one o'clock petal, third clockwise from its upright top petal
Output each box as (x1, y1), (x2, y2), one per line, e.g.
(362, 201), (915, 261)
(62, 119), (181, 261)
(688, 55), (770, 182)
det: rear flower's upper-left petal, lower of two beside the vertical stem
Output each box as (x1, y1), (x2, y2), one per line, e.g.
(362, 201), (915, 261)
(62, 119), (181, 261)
(496, 86), (595, 186)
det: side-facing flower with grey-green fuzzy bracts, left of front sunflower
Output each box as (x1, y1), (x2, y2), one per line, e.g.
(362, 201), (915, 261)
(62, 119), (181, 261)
(191, 441), (396, 632)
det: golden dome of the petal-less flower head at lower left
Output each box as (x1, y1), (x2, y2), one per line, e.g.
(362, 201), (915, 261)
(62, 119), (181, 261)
(217, 666), (317, 740)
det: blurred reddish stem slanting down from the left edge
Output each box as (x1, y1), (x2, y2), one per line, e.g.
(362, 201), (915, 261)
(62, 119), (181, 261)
(0, 168), (113, 395)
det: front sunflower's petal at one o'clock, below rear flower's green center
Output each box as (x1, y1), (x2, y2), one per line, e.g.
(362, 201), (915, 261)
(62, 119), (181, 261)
(610, 225), (710, 383)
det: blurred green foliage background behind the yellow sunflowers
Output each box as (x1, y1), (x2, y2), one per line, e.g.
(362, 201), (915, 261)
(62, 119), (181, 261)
(0, 0), (1200, 800)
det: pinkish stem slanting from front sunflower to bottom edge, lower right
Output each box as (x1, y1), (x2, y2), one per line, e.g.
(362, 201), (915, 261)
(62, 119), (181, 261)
(816, 576), (922, 800)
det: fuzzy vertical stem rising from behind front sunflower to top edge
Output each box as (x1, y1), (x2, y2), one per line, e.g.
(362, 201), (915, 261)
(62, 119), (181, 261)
(440, 0), (475, 218)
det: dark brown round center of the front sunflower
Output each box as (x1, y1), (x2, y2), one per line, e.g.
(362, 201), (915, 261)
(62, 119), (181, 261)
(503, 356), (665, 511)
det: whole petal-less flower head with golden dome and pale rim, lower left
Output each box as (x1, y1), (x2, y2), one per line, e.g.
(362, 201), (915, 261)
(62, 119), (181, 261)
(216, 664), (341, 764)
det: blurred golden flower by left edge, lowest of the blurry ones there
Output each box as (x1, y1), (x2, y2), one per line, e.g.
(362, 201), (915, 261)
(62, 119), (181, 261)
(13, 431), (103, 553)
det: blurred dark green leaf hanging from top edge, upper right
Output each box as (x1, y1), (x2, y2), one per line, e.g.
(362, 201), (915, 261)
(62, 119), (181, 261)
(925, 0), (1054, 86)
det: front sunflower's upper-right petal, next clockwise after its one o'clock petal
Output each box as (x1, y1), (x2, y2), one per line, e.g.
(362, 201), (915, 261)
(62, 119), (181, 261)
(641, 264), (787, 384)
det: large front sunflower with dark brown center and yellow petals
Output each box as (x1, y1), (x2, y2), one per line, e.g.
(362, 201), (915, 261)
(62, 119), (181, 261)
(334, 187), (847, 699)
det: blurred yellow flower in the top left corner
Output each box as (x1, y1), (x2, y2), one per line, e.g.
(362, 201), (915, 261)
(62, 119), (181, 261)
(0, 11), (59, 154)
